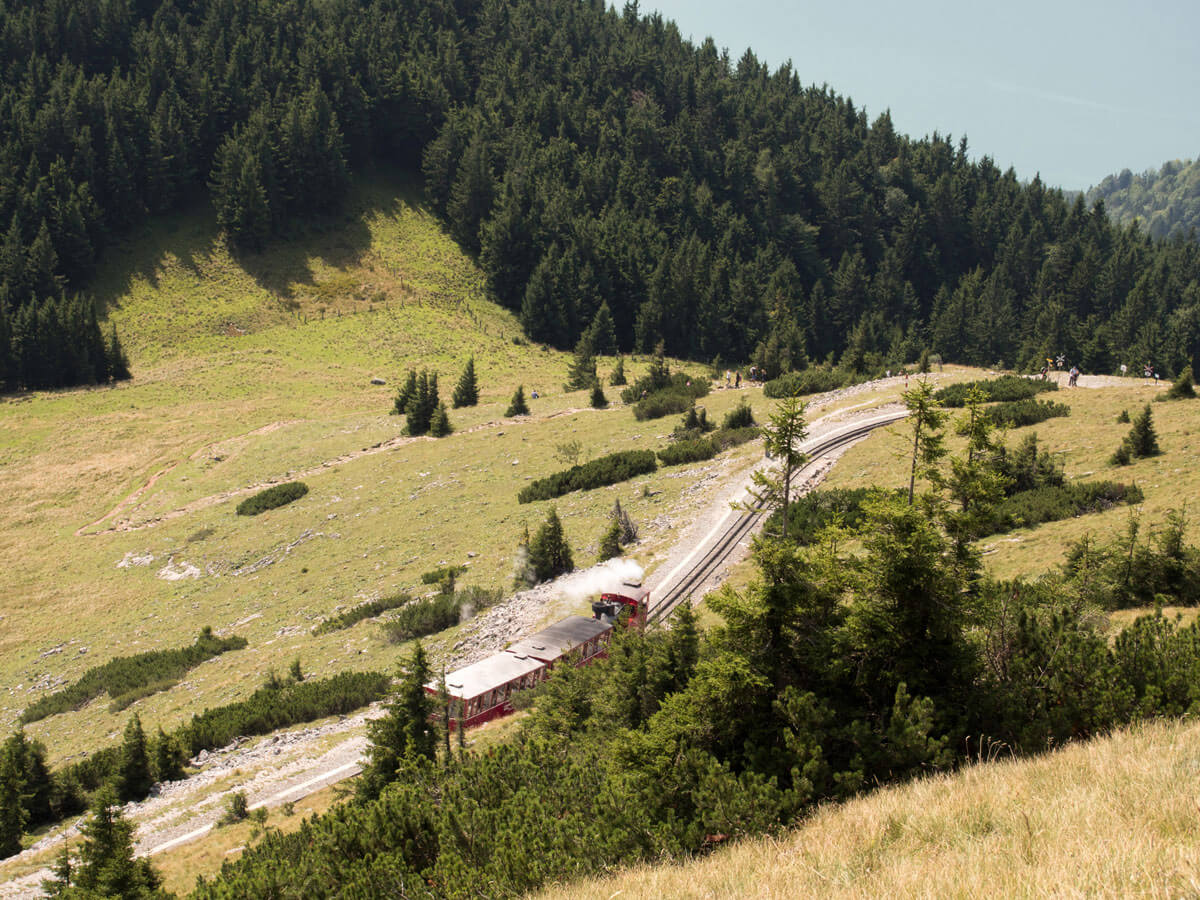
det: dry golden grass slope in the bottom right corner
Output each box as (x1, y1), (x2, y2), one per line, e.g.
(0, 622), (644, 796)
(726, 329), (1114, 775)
(541, 722), (1200, 900)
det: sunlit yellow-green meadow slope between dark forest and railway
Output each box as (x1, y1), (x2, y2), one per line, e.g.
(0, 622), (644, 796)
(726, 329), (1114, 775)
(0, 179), (777, 762)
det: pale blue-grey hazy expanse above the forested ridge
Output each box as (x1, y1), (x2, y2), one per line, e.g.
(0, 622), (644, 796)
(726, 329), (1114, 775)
(648, 0), (1200, 190)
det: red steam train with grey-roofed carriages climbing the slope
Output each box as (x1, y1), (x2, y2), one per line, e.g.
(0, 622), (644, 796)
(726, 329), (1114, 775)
(425, 583), (650, 728)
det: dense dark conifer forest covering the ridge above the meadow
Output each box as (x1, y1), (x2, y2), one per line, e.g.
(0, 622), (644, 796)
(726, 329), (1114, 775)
(0, 0), (1200, 386)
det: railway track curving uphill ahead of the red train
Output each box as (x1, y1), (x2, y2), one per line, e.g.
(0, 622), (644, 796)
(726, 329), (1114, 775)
(647, 412), (907, 622)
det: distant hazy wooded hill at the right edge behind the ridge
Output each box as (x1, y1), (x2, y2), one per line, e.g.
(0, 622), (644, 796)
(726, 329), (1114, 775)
(1087, 160), (1200, 238)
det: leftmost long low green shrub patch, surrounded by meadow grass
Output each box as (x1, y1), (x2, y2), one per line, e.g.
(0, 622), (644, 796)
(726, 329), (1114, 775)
(20, 628), (246, 725)
